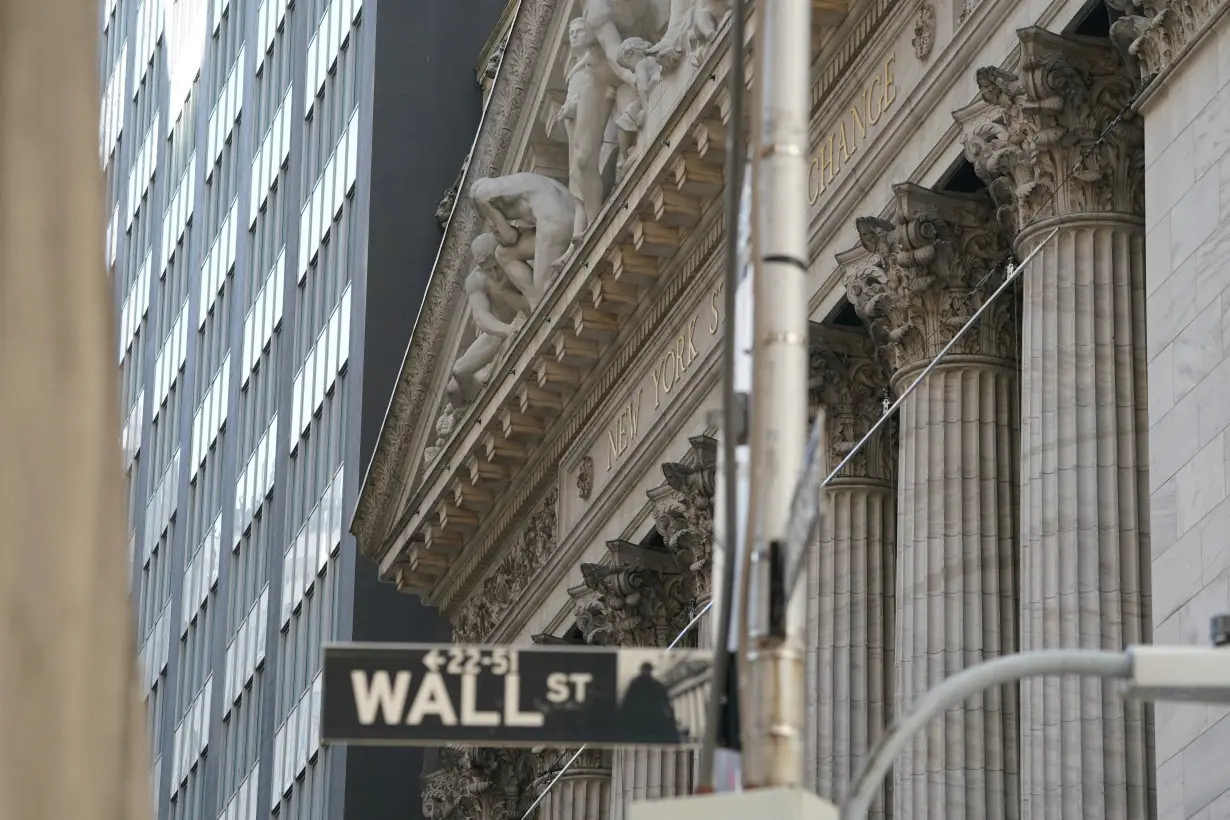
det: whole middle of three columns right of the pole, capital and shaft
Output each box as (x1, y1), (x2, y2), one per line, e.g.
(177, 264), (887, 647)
(846, 184), (1017, 820)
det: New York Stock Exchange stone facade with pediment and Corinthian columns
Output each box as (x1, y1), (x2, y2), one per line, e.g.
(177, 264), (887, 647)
(354, 0), (1230, 820)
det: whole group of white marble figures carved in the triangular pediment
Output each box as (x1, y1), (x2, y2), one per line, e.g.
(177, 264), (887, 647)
(424, 0), (731, 462)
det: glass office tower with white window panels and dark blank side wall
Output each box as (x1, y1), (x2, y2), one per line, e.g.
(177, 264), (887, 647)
(98, 0), (503, 820)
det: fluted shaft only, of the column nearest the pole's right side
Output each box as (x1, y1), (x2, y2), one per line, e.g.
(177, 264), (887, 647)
(807, 477), (897, 819)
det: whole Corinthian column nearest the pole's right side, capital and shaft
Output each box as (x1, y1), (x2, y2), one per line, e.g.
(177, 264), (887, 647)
(806, 327), (897, 818)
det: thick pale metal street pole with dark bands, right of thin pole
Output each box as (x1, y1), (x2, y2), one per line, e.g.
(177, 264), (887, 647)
(740, 0), (812, 787)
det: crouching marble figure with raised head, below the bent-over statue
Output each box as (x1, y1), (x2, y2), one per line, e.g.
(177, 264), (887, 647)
(448, 234), (531, 406)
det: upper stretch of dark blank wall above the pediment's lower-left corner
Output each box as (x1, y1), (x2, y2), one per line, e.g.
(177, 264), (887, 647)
(359, 0), (506, 463)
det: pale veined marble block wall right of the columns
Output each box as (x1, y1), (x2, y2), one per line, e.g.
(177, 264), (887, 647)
(1144, 8), (1230, 820)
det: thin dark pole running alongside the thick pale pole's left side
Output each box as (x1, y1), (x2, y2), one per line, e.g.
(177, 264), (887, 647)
(696, 0), (747, 793)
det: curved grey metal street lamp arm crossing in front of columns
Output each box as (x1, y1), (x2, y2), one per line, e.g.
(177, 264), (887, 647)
(841, 649), (1133, 820)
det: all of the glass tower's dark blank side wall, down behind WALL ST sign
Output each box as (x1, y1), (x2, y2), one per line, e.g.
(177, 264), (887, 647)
(343, 0), (504, 820)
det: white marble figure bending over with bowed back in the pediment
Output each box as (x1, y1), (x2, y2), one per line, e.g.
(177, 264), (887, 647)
(470, 172), (577, 312)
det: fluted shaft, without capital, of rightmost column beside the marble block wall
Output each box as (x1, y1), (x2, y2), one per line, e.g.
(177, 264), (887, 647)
(1021, 214), (1153, 820)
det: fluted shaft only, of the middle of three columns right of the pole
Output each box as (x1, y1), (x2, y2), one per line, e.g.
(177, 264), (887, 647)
(893, 357), (1018, 820)
